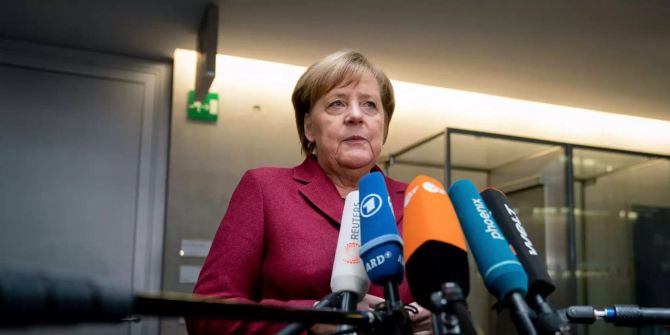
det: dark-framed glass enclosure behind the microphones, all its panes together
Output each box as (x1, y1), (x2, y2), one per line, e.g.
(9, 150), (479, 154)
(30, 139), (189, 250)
(389, 132), (670, 335)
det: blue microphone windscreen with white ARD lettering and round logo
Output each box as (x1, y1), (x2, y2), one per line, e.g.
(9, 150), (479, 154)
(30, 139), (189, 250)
(358, 172), (404, 285)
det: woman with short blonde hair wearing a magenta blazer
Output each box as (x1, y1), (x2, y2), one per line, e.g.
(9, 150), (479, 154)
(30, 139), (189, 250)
(188, 51), (430, 334)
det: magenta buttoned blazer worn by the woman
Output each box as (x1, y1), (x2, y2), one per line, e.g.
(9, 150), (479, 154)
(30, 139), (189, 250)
(187, 156), (414, 334)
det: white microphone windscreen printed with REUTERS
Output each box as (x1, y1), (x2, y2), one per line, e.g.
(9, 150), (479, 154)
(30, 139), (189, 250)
(330, 191), (370, 301)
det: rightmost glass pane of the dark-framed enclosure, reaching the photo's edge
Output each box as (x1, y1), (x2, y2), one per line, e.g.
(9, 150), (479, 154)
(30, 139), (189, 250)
(573, 149), (670, 334)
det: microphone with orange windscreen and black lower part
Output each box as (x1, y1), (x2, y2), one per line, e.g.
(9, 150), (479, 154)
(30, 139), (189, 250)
(403, 176), (476, 334)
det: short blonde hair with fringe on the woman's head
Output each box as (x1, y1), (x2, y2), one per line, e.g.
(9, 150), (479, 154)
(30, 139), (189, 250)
(291, 50), (395, 155)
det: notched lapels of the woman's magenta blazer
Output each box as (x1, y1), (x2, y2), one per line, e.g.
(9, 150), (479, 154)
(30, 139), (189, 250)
(293, 155), (407, 225)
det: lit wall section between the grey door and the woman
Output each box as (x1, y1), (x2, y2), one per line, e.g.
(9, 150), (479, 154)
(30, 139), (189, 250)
(162, 52), (302, 334)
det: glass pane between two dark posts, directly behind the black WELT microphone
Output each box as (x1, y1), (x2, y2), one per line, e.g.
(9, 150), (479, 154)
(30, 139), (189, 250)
(451, 133), (570, 334)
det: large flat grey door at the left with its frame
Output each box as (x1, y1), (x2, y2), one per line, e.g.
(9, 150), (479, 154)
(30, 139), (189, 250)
(0, 40), (169, 334)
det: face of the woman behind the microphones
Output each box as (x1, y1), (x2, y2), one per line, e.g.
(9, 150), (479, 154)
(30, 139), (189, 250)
(305, 75), (385, 169)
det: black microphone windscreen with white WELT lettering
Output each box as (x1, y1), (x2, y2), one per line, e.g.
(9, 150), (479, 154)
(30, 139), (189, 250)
(481, 188), (556, 298)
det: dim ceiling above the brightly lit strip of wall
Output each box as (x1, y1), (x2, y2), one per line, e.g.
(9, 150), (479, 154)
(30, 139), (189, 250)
(5, 0), (670, 120)
